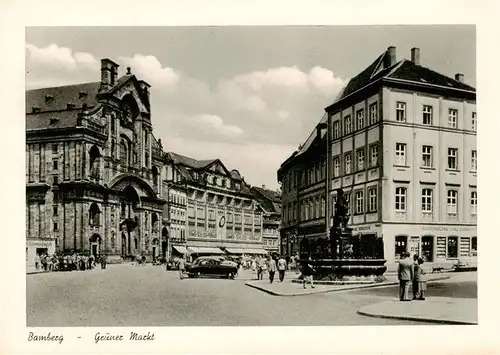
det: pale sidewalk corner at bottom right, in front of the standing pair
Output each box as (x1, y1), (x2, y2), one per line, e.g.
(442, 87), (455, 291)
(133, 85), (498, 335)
(358, 297), (477, 324)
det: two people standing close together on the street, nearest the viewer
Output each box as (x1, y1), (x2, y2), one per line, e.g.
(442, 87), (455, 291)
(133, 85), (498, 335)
(398, 252), (427, 301)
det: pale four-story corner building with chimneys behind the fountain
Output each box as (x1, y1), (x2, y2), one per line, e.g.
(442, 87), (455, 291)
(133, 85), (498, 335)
(326, 47), (478, 263)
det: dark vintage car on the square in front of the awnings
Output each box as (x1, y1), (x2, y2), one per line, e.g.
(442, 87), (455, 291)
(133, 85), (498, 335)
(186, 256), (238, 279)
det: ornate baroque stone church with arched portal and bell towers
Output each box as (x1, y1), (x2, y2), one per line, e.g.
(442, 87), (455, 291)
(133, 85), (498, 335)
(26, 59), (166, 265)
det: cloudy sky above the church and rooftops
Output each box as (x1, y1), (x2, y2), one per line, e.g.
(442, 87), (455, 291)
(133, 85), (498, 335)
(26, 26), (476, 188)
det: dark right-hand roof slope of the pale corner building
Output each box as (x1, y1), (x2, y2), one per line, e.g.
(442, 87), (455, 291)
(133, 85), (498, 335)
(387, 60), (476, 91)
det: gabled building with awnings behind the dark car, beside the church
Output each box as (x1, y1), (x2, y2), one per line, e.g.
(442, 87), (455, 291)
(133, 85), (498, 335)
(164, 152), (266, 255)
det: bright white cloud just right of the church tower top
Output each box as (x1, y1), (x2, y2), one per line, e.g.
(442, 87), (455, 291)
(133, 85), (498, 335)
(120, 54), (180, 88)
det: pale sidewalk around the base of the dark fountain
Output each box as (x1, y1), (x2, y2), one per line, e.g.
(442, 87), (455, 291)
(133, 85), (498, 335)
(245, 274), (450, 296)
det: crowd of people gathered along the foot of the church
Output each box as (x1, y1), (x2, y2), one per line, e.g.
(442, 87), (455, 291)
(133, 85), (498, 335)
(35, 253), (107, 271)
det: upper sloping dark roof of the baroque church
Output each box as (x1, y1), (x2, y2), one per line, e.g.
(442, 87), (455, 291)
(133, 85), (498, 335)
(26, 82), (101, 114)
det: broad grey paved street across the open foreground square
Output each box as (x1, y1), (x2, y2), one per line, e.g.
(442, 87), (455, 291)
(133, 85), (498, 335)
(26, 265), (474, 326)
